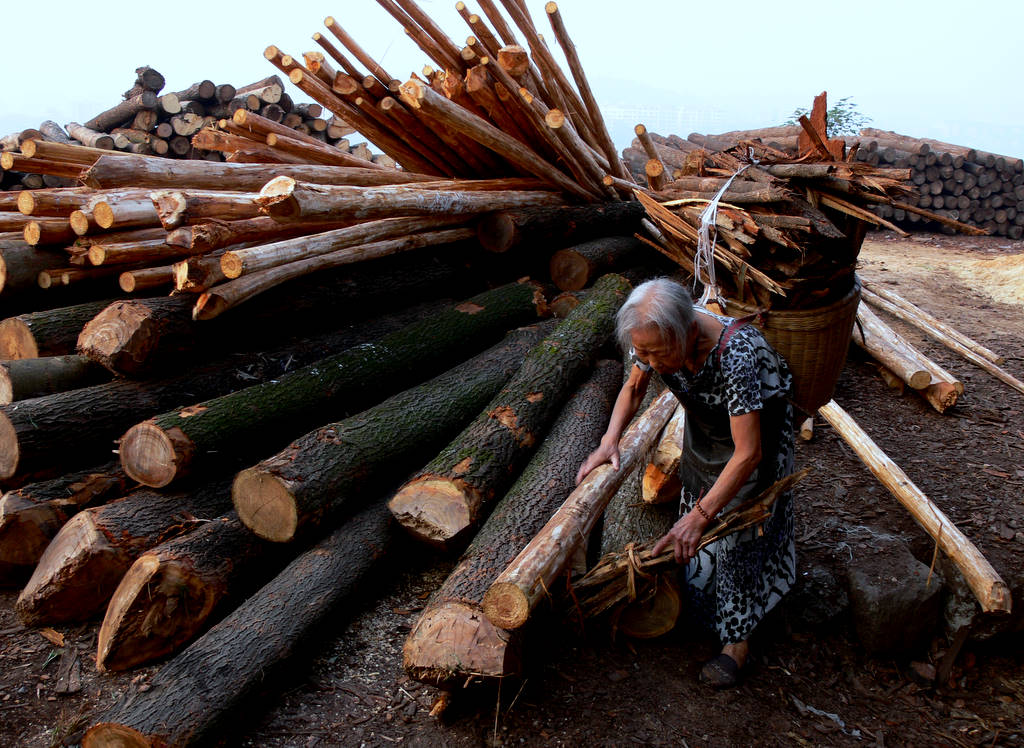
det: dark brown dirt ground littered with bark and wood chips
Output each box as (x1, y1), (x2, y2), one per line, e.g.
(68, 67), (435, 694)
(0, 233), (1024, 748)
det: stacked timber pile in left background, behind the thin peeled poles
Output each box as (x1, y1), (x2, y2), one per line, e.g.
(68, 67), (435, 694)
(0, 67), (368, 190)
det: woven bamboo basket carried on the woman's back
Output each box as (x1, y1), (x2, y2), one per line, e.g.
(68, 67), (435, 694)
(727, 277), (860, 415)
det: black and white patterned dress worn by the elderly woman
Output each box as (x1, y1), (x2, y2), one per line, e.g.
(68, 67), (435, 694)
(634, 307), (796, 643)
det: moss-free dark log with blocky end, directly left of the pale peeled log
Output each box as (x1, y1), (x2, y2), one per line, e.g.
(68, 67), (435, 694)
(402, 362), (622, 685)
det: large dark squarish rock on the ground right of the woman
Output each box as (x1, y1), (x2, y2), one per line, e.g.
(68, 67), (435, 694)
(847, 529), (944, 654)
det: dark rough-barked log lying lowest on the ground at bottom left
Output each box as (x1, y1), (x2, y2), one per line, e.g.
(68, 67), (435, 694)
(82, 503), (395, 748)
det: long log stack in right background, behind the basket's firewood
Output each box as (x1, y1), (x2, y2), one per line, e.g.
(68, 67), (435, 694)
(623, 125), (1024, 239)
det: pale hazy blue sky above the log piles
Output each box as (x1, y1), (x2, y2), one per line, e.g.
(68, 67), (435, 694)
(0, 0), (1024, 157)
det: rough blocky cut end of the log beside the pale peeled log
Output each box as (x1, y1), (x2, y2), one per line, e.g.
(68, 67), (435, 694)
(402, 602), (521, 687)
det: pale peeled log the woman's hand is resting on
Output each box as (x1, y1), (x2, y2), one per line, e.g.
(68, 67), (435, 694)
(483, 391), (678, 629)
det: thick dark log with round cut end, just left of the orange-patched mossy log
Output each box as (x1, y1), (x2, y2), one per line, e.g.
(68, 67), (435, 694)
(231, 322), (552, 542)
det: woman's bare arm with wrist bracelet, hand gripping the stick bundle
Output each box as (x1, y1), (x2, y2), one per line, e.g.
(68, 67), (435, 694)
(653, 411), (761, 564)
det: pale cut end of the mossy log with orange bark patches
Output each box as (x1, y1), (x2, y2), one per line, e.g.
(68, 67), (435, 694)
(388, 476), (472, 548)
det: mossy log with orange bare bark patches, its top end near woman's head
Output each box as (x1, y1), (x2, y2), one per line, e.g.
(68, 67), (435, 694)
(388, 276), (630, 547)
